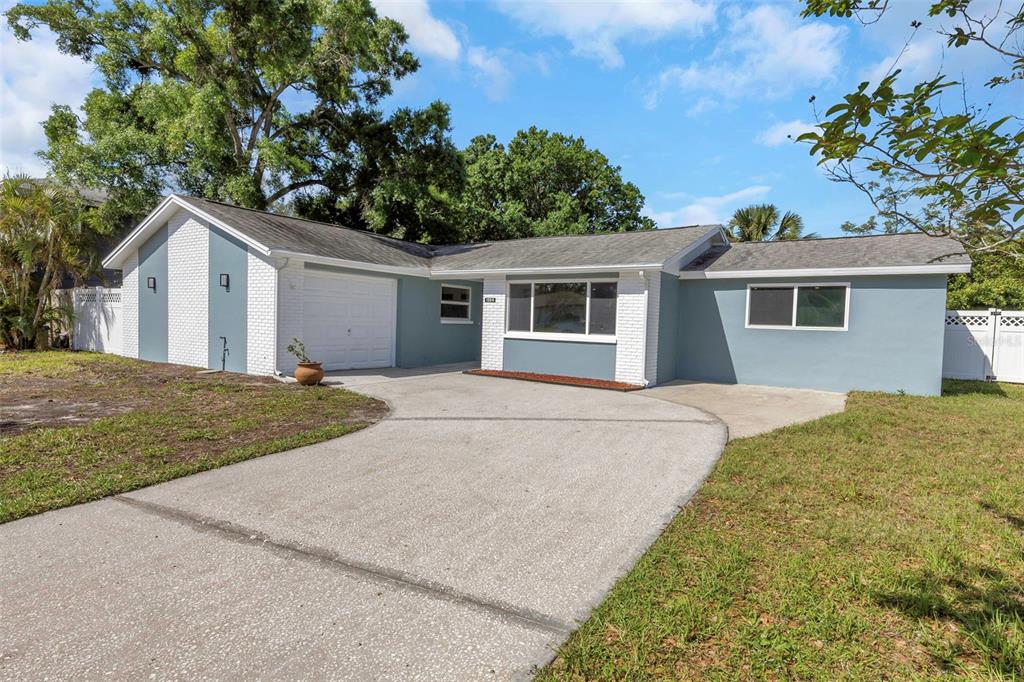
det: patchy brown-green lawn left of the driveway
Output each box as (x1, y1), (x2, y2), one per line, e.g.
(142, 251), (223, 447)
(0, 352), (386, 522)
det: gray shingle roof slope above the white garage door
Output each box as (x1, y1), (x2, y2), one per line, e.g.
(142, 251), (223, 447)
(181, 197), (430, 268)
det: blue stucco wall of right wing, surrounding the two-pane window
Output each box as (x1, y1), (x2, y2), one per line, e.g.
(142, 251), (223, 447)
(675, 274), (946, 395)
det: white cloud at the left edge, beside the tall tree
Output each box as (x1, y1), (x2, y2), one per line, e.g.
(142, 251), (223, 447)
(0, 25), (93, 175)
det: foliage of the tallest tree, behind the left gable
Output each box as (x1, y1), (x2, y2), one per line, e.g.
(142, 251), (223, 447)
(6, 0), (454, 237)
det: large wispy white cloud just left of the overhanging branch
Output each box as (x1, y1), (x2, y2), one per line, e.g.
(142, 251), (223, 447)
(644, 4), (845, 111)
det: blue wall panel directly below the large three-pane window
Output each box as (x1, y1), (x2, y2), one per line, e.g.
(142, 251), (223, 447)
(503, 339), (615, 381)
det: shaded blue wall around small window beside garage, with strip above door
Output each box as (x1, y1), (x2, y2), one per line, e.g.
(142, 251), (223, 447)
(305, 263), (483, 368)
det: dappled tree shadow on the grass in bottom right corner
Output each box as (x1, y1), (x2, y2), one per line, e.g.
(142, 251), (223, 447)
(874, 503), (1024, 679)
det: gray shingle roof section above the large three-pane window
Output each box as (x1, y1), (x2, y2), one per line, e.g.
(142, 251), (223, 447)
(430, 225), (720, 272)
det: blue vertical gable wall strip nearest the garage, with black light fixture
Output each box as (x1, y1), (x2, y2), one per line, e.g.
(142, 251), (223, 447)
(207, 227), (249, 372)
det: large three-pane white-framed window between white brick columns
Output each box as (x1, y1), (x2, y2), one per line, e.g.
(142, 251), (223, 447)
(506, 281), (618, 339)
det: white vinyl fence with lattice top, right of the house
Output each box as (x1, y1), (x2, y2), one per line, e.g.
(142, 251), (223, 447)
(942, 308), (1024, 383)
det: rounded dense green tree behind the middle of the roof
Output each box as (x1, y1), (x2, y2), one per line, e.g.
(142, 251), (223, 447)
(455, 127), (654, 242)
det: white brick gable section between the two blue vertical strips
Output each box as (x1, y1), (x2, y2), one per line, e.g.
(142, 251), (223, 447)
(167, 211), (210, 367)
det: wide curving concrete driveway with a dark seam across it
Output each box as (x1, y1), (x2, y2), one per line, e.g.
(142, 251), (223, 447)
(0, 373), (726, 679)
